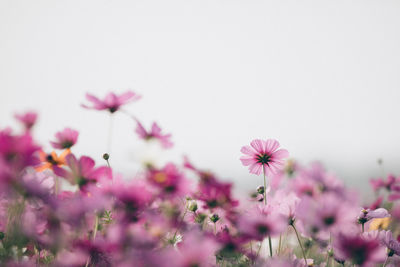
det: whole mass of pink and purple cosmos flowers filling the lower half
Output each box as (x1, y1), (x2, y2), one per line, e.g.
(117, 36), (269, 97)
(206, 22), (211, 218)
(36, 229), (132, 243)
(0, 91), (400, 267)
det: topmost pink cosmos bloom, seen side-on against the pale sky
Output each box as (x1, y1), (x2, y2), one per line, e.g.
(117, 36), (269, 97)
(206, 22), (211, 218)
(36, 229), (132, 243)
(82, 91), (141, 113)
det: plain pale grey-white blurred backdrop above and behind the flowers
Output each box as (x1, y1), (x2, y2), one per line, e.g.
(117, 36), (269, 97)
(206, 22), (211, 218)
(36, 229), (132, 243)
(0, 0), (400, 201)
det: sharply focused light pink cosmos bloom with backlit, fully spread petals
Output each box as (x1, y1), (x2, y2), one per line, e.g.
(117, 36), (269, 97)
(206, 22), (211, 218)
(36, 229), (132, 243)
(240, 139), (289, 175)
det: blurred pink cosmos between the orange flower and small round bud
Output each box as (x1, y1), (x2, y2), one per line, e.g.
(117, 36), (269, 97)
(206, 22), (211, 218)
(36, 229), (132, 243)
(53, 154), (112, 191)
